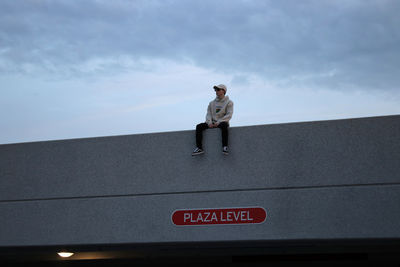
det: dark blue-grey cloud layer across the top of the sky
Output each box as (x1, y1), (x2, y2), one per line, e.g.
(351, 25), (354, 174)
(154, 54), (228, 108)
(0, 0), (400, 90)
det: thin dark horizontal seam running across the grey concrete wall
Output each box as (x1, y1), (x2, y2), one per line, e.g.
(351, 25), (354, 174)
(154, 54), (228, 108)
(0, 183), (400, 204)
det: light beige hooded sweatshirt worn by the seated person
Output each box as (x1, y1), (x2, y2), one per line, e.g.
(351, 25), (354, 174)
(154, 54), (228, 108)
(206, 96), (233, 125)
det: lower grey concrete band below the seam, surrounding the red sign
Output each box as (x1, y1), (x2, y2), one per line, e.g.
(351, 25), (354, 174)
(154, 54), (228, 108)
(0, 186), (400, 246)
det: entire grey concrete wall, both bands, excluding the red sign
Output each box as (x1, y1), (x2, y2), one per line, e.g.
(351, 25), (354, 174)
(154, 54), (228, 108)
(0, 116), (400, 246)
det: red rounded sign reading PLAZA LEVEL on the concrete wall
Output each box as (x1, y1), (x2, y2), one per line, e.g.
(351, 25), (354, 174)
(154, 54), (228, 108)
(172, 207), (267, 225)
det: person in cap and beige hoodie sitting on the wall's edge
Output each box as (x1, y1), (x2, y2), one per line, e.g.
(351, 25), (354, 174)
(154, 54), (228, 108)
(192, 84), (233, 156)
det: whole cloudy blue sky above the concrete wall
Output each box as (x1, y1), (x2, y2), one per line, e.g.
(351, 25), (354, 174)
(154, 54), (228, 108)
(0, 0), (400, 144)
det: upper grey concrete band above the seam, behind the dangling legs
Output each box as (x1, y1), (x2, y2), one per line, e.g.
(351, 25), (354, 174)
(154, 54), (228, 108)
(0, 116), (400, 201)
